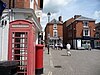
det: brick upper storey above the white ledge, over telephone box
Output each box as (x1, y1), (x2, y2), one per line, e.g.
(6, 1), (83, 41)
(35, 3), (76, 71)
(3, 0), (43, 10)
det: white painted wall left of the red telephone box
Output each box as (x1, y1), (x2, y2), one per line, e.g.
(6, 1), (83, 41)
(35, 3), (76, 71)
(0, 16), (9, 60)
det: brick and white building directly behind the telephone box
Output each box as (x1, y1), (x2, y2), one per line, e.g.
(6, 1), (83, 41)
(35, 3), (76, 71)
(0, 0), (43, 60)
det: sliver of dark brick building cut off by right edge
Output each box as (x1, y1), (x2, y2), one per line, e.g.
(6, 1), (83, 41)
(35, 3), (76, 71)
(95, 22), (100, 48)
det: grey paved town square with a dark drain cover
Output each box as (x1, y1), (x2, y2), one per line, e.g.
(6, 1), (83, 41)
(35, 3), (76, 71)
(42, 48), (100, 75)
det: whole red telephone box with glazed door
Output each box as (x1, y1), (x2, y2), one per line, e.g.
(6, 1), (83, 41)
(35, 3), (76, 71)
(8, 20), (35, 75)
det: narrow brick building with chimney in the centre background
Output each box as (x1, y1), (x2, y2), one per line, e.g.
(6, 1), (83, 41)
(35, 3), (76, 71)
(45, 16), (63, 46)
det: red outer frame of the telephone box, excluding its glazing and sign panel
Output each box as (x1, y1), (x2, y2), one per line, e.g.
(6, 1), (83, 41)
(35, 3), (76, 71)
(8, 20), (35, 75)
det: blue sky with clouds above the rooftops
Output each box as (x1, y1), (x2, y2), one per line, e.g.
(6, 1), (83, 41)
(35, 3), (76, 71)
(41, 0), (100, 30)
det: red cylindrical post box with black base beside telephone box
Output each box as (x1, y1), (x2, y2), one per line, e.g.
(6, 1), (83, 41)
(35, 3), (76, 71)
(35, 44), (44, 74)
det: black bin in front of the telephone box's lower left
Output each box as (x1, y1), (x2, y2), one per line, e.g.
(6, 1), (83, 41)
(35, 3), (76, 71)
(0, 61), (18, 75)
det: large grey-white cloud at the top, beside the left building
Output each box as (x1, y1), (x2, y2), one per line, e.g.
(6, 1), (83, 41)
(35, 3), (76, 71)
(43, 0), (72, 13)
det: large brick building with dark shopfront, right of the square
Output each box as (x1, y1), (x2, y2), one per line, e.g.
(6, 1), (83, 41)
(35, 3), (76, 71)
(63, 15), (95, 49)
